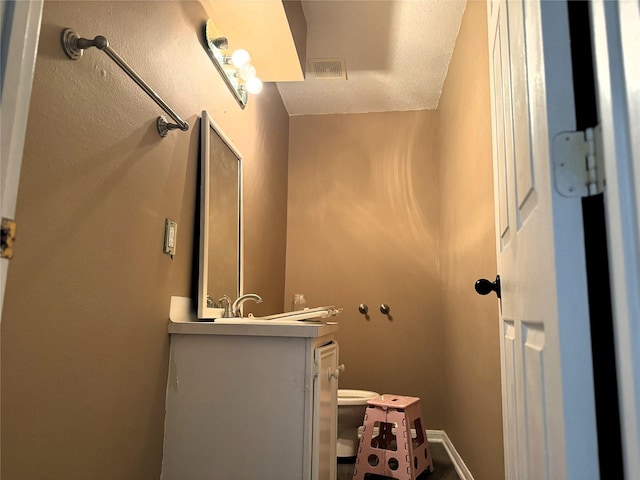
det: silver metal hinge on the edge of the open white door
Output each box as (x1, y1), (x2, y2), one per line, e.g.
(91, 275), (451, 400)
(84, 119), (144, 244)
(553, 125), (605, 197)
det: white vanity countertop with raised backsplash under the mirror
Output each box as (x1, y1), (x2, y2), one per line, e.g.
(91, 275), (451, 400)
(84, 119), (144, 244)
(169, 296), (338, 337)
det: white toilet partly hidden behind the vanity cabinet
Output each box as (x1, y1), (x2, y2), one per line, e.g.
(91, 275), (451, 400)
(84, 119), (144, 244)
(336, 389), (380, 457)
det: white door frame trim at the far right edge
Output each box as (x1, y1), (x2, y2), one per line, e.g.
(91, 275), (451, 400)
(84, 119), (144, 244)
(591, 0), (640, 479)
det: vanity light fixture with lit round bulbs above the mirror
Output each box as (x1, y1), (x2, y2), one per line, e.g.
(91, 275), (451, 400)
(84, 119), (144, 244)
(204, 19), (262, 108)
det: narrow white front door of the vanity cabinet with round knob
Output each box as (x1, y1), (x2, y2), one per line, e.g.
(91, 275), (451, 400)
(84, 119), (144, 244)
(312, 342), (340, 480)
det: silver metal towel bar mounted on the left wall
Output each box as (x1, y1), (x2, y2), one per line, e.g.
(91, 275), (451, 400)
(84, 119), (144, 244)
(61, 28), (189, 137)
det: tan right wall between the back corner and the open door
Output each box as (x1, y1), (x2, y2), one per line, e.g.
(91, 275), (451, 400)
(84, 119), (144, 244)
(437, 1), (504, 480)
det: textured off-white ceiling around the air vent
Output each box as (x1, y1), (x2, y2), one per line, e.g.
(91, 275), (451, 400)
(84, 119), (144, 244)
(277, 0), (466, 115)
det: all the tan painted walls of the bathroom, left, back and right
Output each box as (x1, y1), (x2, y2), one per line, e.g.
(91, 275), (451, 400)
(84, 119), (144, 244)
(1, 1), (503, 480)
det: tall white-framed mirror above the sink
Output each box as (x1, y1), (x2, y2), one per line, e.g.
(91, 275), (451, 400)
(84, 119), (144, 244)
(198, 111), (242, 320)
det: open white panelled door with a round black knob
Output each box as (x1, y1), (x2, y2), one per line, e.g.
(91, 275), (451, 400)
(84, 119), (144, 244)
(487, 0), (599, 480)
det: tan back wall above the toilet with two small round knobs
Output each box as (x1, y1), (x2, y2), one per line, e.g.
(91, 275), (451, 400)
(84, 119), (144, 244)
(285, 110), (445, 429)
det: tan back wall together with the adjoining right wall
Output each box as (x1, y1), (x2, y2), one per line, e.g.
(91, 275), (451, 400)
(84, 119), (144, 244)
(285, 1), (504, 480)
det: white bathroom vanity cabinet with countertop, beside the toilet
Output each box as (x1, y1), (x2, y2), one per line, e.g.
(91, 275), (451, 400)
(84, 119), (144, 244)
(162, 322), (339, 480)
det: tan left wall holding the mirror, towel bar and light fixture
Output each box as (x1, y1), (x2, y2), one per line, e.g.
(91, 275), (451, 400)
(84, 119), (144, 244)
(1, 1), (288, 480)
